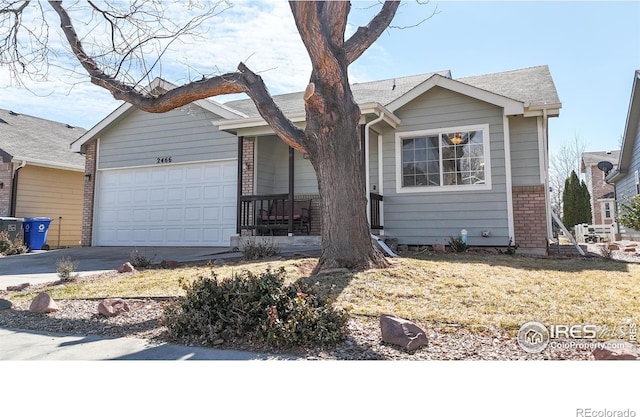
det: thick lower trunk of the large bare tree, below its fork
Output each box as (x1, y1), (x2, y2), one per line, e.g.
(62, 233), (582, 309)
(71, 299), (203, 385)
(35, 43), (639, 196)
(306, 73), (387, 273)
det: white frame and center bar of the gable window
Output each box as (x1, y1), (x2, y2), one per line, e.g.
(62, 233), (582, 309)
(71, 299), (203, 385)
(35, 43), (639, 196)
(395, 124), (492, 194)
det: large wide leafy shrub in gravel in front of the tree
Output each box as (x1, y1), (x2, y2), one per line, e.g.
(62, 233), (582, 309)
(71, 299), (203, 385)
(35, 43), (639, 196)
(162, 268), (348, 348)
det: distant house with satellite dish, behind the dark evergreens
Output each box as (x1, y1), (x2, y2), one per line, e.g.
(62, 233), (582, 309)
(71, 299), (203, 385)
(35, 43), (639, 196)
(580, 151), (620, 224)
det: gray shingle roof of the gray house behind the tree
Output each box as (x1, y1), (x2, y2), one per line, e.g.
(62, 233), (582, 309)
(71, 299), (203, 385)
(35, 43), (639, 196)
(225, 65), (560, 117)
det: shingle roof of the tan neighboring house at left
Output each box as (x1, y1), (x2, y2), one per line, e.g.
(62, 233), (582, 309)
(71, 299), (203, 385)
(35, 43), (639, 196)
(0, 109), (86, 171)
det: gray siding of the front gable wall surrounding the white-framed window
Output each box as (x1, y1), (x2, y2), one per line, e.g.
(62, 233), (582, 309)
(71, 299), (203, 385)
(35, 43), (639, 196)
(383, 87), (509, 245)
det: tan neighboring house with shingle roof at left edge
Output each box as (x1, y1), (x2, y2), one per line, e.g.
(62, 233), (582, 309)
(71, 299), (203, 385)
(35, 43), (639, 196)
(0, 110), (86, 248)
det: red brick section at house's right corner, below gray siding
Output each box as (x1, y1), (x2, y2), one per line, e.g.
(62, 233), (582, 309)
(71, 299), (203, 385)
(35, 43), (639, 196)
(513, 185), (549, 255)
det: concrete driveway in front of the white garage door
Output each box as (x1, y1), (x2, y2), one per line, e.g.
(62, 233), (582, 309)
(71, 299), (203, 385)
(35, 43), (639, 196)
(0, 247), (242, 290)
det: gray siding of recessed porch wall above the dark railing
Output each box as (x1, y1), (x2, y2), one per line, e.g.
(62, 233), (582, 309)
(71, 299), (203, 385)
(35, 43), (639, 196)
(256, 136), (318, 195)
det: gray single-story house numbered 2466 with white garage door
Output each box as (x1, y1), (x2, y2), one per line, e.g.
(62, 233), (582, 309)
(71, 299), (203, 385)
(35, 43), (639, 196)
(72, 66), (561, 254)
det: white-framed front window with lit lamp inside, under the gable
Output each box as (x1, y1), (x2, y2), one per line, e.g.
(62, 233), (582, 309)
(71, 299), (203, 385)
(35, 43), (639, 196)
(396, 126), (489, 192)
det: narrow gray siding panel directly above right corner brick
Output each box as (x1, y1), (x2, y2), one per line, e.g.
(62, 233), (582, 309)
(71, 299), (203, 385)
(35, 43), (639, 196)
(509, 117), (541, 186)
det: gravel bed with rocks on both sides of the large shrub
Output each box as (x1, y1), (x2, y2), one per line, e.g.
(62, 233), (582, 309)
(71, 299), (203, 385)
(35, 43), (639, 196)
(0, 294), (591, 360)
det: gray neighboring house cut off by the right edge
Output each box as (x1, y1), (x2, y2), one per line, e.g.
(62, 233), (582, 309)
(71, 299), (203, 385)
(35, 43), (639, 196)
(606, 70), (640, 240)
